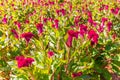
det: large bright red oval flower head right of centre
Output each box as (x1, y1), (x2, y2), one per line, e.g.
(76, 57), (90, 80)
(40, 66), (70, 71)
(88, 29), (99, 45)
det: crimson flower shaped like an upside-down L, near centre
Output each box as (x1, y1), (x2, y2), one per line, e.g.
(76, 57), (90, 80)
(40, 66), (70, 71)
(66, 30), (79, 47)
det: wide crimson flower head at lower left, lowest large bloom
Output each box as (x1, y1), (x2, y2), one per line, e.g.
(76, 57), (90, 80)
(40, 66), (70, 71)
(15, 56), (34, 68)
